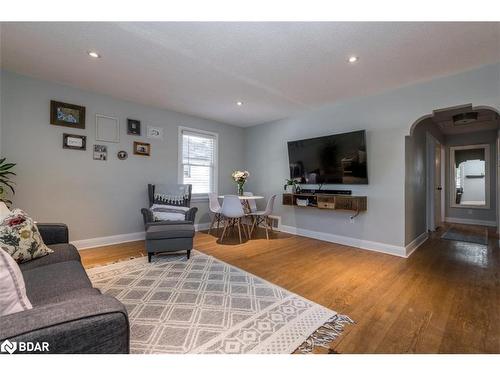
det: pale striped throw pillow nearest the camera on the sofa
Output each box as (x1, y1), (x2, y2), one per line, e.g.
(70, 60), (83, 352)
(0, 248), (33, 316)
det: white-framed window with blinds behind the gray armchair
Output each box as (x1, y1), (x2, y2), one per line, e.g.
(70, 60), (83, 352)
(179, 127), (218, 198)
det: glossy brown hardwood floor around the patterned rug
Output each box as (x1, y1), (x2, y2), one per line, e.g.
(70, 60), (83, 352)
(81, 225), (500, 353)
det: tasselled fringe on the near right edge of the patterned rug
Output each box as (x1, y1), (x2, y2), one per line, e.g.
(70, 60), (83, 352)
(295, 314), (354, 354)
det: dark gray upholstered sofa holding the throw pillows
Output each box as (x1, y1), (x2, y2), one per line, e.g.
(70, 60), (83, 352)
(0, 224), (130, 353)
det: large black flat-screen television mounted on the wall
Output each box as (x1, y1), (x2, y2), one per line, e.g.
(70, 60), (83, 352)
(288, 130), (368, 184)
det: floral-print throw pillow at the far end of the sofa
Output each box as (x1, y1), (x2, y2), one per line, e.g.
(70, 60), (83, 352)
(0, 208), (53, 263)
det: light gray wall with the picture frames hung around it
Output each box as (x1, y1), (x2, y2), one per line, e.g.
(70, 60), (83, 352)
(1, 71), (244, 240)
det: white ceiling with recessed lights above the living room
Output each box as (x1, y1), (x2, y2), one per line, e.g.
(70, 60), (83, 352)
(1, 22), (500, 126)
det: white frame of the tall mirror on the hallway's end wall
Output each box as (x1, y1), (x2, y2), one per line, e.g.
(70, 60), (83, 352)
(449, 143), (491, 210)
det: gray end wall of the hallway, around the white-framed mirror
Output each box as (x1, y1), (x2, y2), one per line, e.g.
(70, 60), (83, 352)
(445, 130), (497, 222)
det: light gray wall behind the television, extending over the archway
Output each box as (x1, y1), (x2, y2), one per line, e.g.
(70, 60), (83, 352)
(246, 64), (500, 246)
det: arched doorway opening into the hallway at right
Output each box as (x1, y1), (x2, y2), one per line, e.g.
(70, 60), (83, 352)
(405, 104), (500, 250)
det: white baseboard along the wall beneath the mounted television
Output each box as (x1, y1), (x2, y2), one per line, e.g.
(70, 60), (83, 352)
(279, 225), (407, 258)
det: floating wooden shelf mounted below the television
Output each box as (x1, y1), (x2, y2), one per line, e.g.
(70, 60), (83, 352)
(283, 193), (367, 218)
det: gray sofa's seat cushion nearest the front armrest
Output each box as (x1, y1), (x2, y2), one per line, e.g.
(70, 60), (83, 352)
(23, 261), (92, 307)
